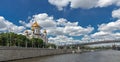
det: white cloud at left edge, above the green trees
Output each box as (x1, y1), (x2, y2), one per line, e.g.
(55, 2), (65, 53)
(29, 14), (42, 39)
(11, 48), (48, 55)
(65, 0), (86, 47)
(0, 16), (25, 33)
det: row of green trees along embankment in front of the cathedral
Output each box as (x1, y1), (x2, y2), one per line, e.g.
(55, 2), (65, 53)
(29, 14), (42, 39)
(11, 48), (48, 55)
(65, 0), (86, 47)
(0, 32), (56, 48)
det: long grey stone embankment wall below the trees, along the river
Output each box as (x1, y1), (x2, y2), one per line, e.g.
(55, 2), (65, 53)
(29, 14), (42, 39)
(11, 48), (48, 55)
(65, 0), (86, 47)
(0, 47), (71, 61)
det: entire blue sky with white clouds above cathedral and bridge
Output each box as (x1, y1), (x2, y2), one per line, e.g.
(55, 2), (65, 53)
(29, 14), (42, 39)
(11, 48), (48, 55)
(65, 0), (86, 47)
(0, 0), (120, 45)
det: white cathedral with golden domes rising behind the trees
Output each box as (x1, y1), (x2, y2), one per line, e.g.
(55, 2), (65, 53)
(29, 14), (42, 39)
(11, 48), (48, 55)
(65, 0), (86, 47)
(25, 21), (48, 43)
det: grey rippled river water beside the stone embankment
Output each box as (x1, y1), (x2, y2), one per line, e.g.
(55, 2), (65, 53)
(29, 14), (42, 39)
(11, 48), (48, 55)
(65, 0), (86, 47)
(10, 50), (120, 62)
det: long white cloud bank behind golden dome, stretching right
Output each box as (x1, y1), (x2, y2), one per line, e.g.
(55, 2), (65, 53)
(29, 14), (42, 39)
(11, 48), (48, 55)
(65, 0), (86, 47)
(20, 13), (94, 36)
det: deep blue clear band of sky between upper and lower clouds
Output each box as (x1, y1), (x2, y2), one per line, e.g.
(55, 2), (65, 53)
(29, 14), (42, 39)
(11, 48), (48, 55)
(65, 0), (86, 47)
(0, 0), (116, 26)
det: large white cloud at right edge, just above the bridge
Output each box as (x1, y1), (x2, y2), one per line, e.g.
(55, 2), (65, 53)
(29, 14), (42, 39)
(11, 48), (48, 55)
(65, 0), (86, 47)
(90, 20), (120, 40)
